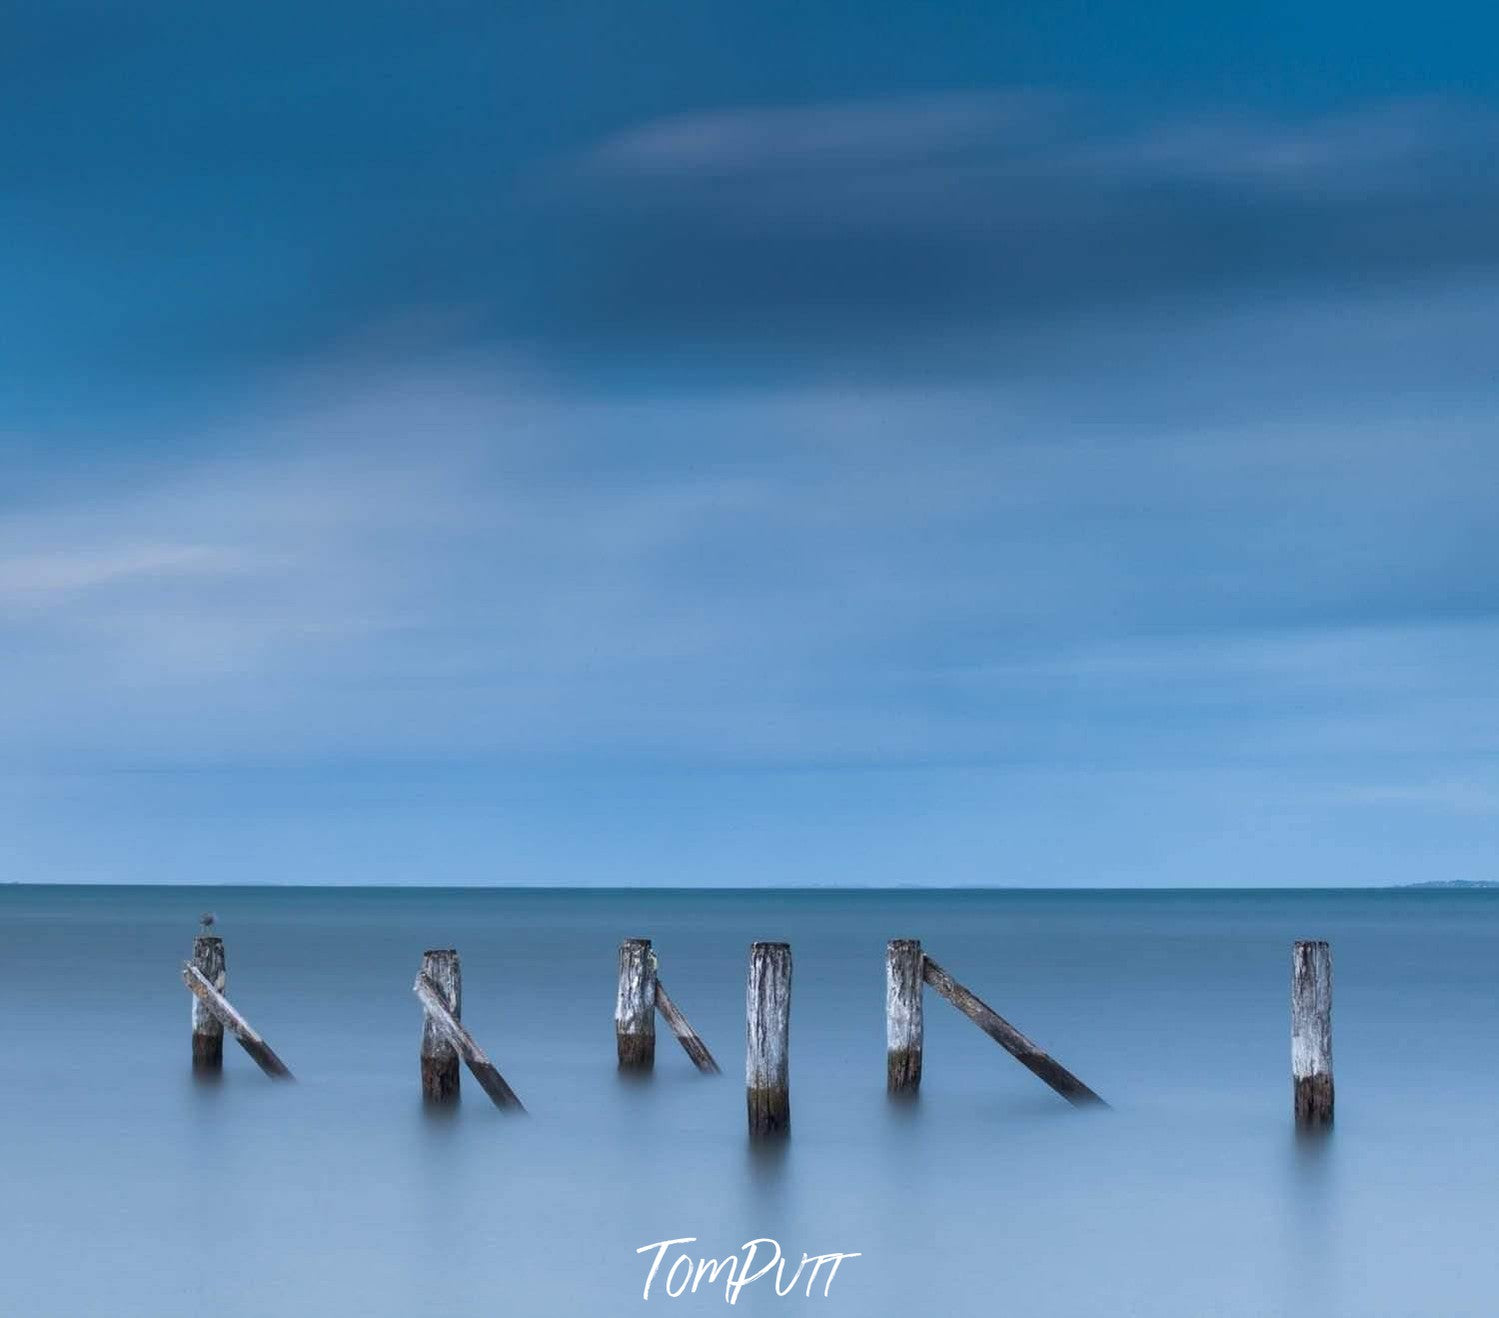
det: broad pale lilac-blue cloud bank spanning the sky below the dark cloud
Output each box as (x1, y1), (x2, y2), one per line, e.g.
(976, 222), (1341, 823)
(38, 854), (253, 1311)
(0, 340), (1495, 765)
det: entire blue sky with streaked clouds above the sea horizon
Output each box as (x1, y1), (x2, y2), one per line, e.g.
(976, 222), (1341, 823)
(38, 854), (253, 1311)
(0, 0), (1499, 888)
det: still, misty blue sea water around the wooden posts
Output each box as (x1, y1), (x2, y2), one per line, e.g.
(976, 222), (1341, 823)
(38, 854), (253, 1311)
(0, 886), (1499, 1318)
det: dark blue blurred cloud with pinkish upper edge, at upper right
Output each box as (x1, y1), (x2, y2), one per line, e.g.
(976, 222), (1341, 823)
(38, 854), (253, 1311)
(515, 94), (1499, 367)
